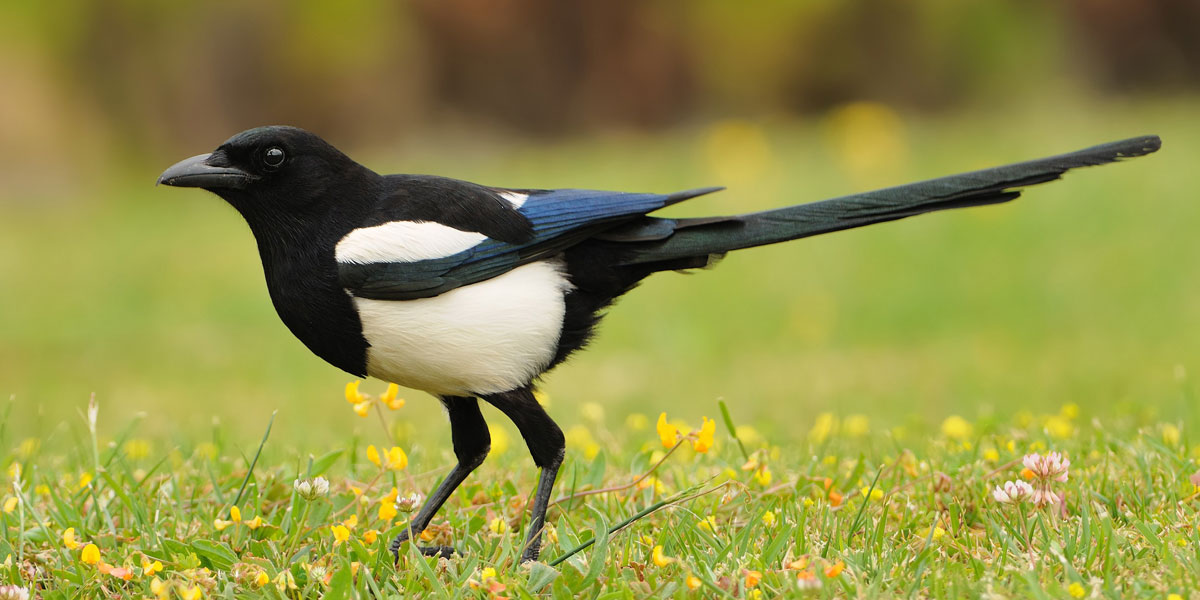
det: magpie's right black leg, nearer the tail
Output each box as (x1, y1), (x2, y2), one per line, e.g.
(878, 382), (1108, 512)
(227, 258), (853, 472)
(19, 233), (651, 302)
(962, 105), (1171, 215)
(482, 386), (566, 563)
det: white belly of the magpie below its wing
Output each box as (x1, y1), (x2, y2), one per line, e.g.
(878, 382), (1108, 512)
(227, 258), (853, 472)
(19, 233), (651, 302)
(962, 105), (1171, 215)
(354, 260), (571, 396)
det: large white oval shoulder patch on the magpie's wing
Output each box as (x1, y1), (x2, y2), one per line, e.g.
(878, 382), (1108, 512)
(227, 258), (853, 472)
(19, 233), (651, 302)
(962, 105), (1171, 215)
(334, 221), (487, 264)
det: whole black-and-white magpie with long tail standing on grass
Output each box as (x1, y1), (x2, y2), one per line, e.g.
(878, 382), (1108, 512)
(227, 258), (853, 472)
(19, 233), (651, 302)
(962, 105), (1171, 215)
(158, 126), (1160, 562)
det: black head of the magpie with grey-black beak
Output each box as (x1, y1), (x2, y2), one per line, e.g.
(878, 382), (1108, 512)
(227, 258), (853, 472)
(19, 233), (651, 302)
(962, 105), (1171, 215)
(158, 126), (373, 224)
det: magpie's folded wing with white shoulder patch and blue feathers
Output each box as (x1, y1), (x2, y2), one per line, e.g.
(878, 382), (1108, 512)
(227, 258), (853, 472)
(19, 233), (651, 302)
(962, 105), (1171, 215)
(337, 178), (719, 300)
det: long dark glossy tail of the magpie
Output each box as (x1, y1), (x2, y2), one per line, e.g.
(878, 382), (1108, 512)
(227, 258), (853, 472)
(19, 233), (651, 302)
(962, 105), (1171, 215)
(614, 136), (1162, 270)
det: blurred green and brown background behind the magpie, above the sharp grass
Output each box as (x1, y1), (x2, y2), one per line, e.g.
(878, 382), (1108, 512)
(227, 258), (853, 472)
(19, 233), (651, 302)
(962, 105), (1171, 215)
(0, 0), (1200, 445)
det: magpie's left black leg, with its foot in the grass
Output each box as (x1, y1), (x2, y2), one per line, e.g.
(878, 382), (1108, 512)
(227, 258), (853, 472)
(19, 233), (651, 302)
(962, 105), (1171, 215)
(391, 396), (492, 558)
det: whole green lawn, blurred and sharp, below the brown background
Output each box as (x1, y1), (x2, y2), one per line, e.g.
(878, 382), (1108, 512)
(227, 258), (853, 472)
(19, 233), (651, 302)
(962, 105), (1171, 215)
(0, 101), (1200, 598)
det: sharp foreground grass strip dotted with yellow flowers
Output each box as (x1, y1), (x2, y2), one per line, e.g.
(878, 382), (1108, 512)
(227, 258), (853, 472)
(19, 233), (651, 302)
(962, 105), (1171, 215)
(0, 386), (1200, 599)
